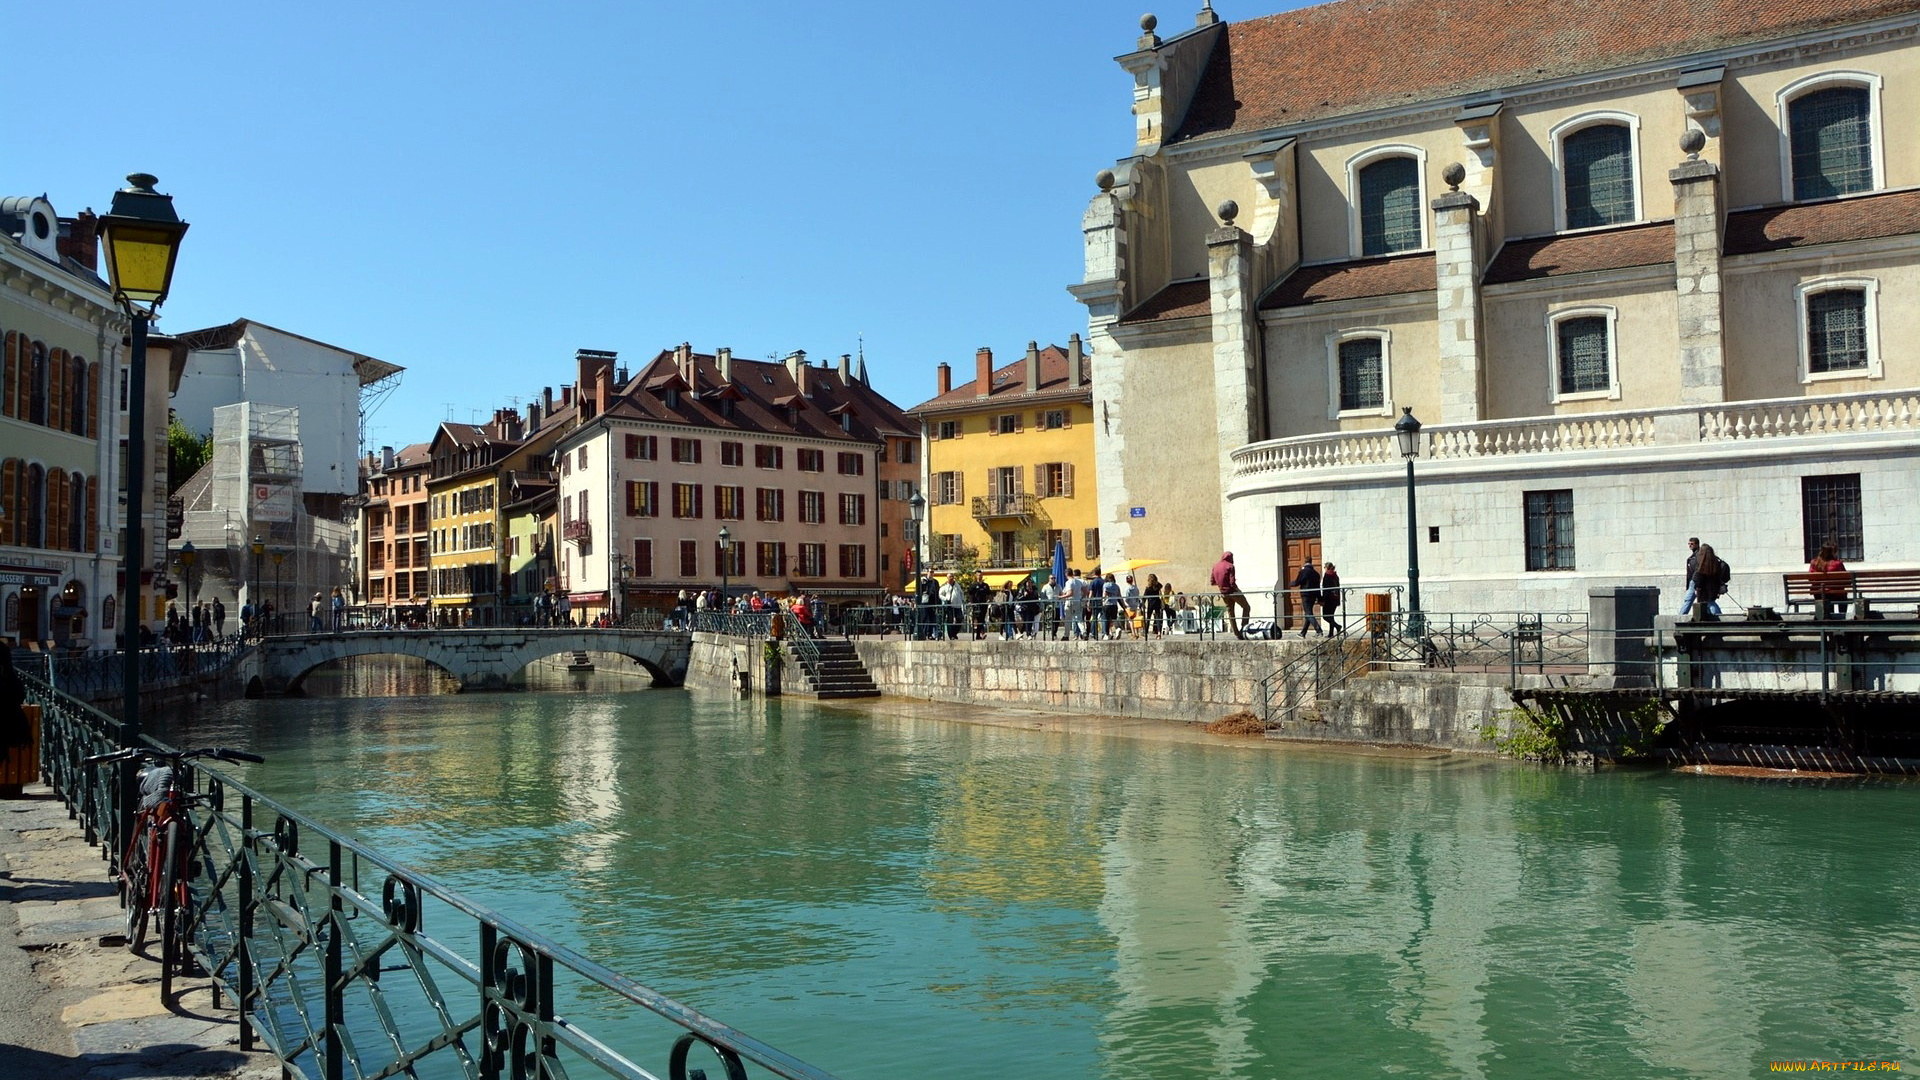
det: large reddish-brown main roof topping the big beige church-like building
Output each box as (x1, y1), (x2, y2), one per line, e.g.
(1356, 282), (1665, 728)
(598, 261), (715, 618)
(1173, 0), (1920, 142)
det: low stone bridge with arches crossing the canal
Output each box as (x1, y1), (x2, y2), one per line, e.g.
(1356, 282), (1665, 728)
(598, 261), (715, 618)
(236, 628), (691, 698)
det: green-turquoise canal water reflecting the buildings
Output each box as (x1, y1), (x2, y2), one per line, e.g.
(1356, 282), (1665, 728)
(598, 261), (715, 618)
(165, 661), (1920, 1080)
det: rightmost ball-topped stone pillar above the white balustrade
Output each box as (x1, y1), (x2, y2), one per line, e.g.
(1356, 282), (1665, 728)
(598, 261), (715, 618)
(1667, 131), (1726, 405)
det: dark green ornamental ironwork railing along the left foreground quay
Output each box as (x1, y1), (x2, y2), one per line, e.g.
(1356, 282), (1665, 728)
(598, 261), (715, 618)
(15, 675), (831, 1080)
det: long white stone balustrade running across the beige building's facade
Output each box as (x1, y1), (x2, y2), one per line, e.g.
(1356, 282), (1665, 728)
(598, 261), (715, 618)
(1228, 382), (1920, 474)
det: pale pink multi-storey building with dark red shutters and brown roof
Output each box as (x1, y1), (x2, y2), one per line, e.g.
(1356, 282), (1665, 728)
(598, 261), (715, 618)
(555, 344), (920, 617)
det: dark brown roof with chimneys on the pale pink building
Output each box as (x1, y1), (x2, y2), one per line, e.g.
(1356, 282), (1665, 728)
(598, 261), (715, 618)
(607, 350), (920, 442)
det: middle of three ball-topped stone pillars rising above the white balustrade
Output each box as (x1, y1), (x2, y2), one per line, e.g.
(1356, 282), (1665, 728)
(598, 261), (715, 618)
(1432, 171), (1486, 425)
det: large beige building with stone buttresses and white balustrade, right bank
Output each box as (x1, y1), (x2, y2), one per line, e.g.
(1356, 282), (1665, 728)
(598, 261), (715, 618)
(1073, 0), (1920, 611)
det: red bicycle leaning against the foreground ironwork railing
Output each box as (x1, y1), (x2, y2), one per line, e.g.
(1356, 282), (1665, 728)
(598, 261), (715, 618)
(86, 748), (265, 999)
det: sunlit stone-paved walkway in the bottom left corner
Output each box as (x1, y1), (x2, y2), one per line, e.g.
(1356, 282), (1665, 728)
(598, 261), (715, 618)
(0, 786), (280, 1080)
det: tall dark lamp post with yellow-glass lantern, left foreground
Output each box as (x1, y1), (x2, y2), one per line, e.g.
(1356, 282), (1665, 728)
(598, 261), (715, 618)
(100, 173), (186, 853)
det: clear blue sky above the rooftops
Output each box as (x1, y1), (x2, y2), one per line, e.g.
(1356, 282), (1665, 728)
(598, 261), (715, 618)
(22, 0), (1236, 446)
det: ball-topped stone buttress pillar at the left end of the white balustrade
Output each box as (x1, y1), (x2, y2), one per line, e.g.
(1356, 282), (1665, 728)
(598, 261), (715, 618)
(1206, 202), (1267, 453)
